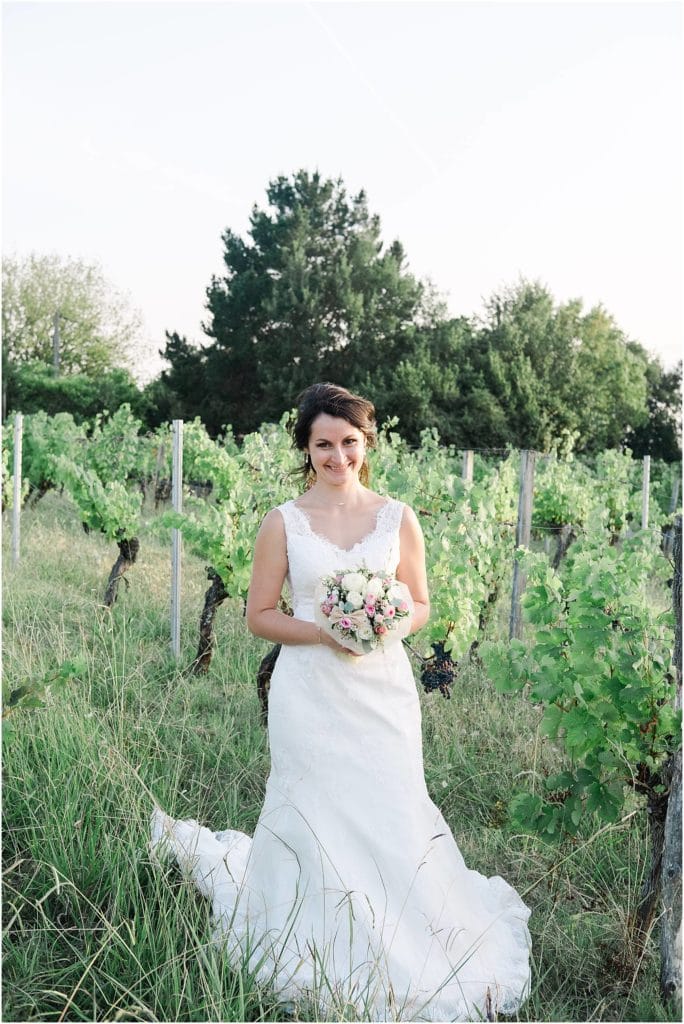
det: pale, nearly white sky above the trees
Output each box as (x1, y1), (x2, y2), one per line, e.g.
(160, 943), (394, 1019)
(2, 0), (684, 379)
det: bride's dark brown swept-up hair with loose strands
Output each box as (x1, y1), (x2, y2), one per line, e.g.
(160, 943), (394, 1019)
(292, 384), (378, 486)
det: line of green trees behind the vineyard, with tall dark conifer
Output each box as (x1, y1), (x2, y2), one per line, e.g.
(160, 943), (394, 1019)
(3, 170), (681, 462)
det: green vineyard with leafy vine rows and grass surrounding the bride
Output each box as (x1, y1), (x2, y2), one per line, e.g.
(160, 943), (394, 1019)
(2, 407), (681, 1020)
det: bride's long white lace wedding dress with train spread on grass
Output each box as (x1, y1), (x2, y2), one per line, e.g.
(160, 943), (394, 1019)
(153, 500), (529, 1021)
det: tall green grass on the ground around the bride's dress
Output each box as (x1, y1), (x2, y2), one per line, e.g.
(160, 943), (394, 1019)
(3, 495), (677, 1021)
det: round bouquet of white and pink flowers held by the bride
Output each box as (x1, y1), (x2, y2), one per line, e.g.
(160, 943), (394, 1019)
(314, 568), (414, 654)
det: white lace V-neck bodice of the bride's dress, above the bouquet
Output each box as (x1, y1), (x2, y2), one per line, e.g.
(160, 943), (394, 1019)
(277, 498), (403, 622)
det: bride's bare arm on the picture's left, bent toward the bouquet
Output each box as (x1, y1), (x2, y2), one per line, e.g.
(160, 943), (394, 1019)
(242, 509), (344, 650)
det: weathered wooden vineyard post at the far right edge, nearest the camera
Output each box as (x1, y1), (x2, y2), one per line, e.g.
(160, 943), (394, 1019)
(660, 515), (682, 1003)
